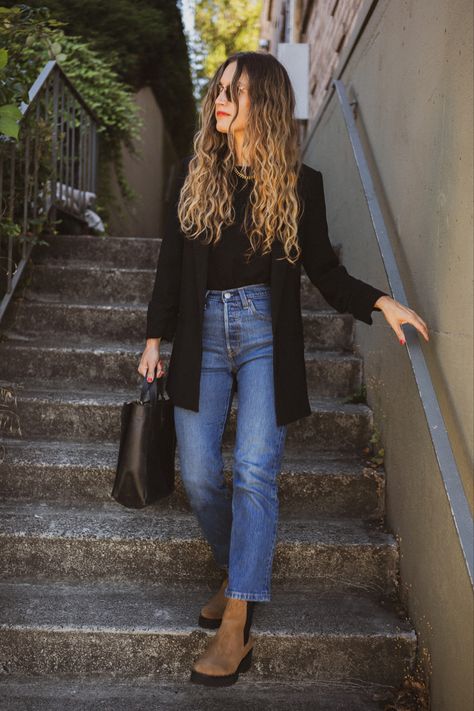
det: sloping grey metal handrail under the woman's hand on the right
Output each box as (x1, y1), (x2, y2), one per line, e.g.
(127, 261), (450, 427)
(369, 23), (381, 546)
(333, 79), (474, 586)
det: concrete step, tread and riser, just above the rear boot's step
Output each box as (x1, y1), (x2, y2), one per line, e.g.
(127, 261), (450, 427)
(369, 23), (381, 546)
(0, 501), (398, 594)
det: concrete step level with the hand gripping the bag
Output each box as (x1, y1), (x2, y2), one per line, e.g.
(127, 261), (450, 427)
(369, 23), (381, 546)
(0, 332), (363, 397)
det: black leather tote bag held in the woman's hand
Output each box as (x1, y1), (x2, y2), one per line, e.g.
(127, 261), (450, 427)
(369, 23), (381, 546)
(112, 375), (176, 508)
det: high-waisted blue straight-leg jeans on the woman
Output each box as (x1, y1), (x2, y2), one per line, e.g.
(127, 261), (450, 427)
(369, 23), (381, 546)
(174, 284), (287, 601)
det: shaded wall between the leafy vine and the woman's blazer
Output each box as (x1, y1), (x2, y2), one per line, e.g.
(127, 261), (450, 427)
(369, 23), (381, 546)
(109, 87), (176, 237)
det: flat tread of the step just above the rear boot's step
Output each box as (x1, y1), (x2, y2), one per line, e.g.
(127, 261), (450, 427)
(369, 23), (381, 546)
(0, 497), (397, 549)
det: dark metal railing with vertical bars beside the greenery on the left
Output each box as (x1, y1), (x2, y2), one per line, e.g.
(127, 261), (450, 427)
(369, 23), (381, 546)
(0, 60), (101, 322)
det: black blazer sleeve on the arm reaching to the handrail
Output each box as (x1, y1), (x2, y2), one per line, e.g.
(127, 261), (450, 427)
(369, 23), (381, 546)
(301, 166), (390, 325)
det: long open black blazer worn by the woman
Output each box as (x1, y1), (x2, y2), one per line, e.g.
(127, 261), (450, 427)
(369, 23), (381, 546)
(146, 156), (388, 425)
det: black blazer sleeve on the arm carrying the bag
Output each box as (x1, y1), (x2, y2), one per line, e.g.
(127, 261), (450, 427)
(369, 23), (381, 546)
(146, 156), (190, 342)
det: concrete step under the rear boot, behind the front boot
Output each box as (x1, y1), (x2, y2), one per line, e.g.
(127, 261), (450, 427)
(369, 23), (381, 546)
(0, 581), (416, 688)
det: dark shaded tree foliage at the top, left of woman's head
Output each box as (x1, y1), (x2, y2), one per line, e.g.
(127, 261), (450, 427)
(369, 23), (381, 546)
(0, 0), (196, 156)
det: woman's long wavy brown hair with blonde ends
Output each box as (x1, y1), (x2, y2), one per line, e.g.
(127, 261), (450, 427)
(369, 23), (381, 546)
(178, 51), (304, 264)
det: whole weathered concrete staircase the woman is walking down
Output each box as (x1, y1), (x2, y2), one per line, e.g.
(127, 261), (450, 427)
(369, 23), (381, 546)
(0, 236), (417, 711)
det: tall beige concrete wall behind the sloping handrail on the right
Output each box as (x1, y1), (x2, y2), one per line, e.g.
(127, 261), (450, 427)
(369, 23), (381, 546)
(262, 0), (474, 711)
